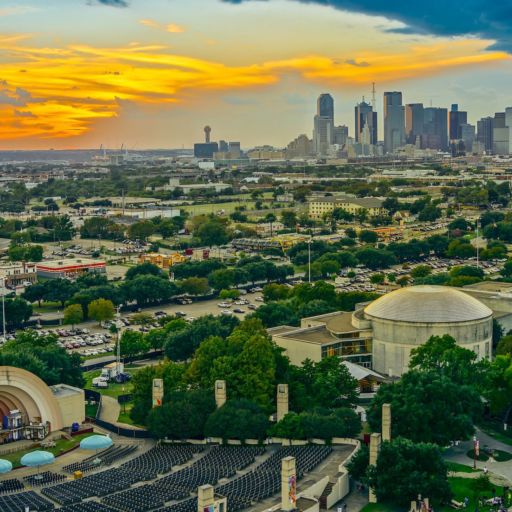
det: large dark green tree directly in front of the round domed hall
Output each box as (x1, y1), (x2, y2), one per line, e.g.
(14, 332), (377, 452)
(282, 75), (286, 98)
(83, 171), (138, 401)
(368, 371), (482, 446)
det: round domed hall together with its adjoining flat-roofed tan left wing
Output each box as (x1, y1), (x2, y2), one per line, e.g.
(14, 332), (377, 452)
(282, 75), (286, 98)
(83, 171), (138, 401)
(269, 286), (493, 377)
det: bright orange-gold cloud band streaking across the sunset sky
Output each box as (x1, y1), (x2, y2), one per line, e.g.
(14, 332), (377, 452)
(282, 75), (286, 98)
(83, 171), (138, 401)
(0, 34), (510, 139)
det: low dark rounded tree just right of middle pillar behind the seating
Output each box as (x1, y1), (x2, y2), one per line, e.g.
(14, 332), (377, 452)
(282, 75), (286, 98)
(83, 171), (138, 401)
(204, 399), (269, 441)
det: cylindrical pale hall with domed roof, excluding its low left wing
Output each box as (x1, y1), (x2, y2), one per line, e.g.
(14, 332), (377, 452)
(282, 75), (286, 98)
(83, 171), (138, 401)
(355, 286), (493, 376)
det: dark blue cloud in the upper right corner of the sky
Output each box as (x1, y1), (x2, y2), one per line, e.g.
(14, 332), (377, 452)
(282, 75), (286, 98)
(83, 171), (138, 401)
(223, 0), (512, 53)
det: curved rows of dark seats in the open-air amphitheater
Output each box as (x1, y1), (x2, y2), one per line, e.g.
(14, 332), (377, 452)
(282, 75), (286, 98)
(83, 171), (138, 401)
(0, 436), (355, 512)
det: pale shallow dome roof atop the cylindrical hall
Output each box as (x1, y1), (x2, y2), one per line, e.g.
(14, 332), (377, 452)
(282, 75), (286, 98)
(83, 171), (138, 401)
(364, 286), (492, 323)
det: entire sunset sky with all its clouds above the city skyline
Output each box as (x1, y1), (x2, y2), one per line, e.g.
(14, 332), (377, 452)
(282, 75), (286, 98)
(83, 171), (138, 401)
(0, 0), (512, 150)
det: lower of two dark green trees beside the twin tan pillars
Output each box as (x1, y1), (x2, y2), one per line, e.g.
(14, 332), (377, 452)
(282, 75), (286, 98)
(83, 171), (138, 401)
(367, 438), (451, 507)
